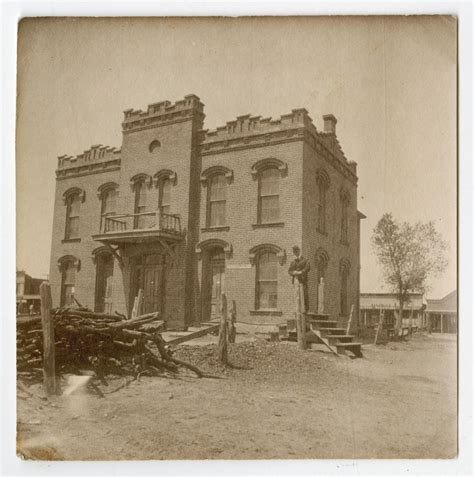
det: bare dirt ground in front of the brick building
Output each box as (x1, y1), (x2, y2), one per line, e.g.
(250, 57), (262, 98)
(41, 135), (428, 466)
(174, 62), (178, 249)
(17, 334), (457, 460)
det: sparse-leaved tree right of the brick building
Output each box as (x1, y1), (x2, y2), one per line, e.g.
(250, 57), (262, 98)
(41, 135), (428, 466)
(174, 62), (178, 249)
(372, 214), (448, 339)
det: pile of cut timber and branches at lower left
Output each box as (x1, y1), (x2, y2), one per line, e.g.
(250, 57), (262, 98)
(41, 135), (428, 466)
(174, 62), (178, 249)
(17, 307), (202, 381)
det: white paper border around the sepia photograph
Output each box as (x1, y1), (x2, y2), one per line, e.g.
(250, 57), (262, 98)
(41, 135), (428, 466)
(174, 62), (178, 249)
(0, 1), (474, 475)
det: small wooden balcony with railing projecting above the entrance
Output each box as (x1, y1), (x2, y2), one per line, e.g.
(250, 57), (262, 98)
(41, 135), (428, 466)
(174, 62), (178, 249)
(92, 211), (184, 246)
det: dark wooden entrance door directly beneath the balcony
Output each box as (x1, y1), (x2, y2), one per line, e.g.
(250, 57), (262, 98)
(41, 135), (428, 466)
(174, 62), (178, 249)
(130, 254), (166, 314)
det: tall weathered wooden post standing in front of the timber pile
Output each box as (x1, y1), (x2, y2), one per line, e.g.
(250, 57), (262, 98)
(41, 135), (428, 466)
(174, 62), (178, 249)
(40, 282), (57, 396)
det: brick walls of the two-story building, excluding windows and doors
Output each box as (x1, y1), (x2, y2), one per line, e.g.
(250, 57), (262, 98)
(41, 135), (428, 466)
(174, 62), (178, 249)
(50, 95), (360, 328)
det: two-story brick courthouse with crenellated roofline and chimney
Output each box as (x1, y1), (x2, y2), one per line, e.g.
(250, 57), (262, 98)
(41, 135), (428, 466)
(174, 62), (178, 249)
(50, 95), (363, 327)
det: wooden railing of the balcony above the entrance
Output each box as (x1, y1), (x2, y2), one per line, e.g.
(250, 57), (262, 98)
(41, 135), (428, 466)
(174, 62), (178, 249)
(100, 211), (182, 234)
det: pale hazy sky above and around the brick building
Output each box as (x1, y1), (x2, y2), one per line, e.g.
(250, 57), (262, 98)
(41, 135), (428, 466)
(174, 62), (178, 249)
(16, 16), (457, 297)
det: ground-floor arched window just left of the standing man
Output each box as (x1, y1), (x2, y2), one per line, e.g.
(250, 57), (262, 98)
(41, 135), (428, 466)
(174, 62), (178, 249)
(255, 250), (278, 310)
